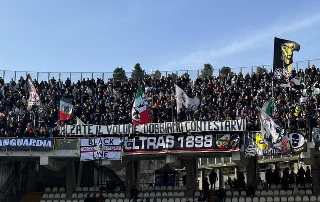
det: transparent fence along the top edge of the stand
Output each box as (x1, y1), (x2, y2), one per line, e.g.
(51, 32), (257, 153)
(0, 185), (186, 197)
(0, 59), (320, 83)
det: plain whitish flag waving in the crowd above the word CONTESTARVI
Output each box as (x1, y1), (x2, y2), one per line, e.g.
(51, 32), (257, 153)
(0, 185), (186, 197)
(176, 85), (200, 114)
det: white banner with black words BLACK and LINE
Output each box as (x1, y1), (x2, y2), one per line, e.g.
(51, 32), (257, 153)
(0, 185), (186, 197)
(80, 137), (122, 161)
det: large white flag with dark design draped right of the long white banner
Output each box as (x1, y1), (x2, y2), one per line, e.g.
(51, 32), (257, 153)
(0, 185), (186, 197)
(259, 109), (288, 152)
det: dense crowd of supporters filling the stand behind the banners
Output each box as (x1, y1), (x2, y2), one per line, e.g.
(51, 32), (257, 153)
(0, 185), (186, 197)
(0, 66), (320, 137)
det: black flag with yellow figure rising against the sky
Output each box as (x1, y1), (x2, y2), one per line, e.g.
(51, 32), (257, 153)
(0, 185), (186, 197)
(273, 37), (300, 82)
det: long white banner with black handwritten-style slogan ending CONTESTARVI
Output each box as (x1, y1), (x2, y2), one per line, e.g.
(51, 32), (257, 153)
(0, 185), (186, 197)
(60, 119), (246, 136)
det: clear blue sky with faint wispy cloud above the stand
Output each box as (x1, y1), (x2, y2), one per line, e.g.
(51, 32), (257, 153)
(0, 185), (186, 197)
(0, 0), (320, 78)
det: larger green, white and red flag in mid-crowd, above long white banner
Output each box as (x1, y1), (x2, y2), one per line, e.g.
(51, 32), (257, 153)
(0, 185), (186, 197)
(132, 88), (153, 125)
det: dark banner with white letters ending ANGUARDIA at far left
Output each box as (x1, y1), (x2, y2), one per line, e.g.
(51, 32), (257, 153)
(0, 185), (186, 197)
(0, 138), (54, 151)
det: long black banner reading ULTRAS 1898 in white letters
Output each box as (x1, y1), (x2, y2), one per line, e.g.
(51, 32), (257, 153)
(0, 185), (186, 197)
(124, 134), (240, 155)
